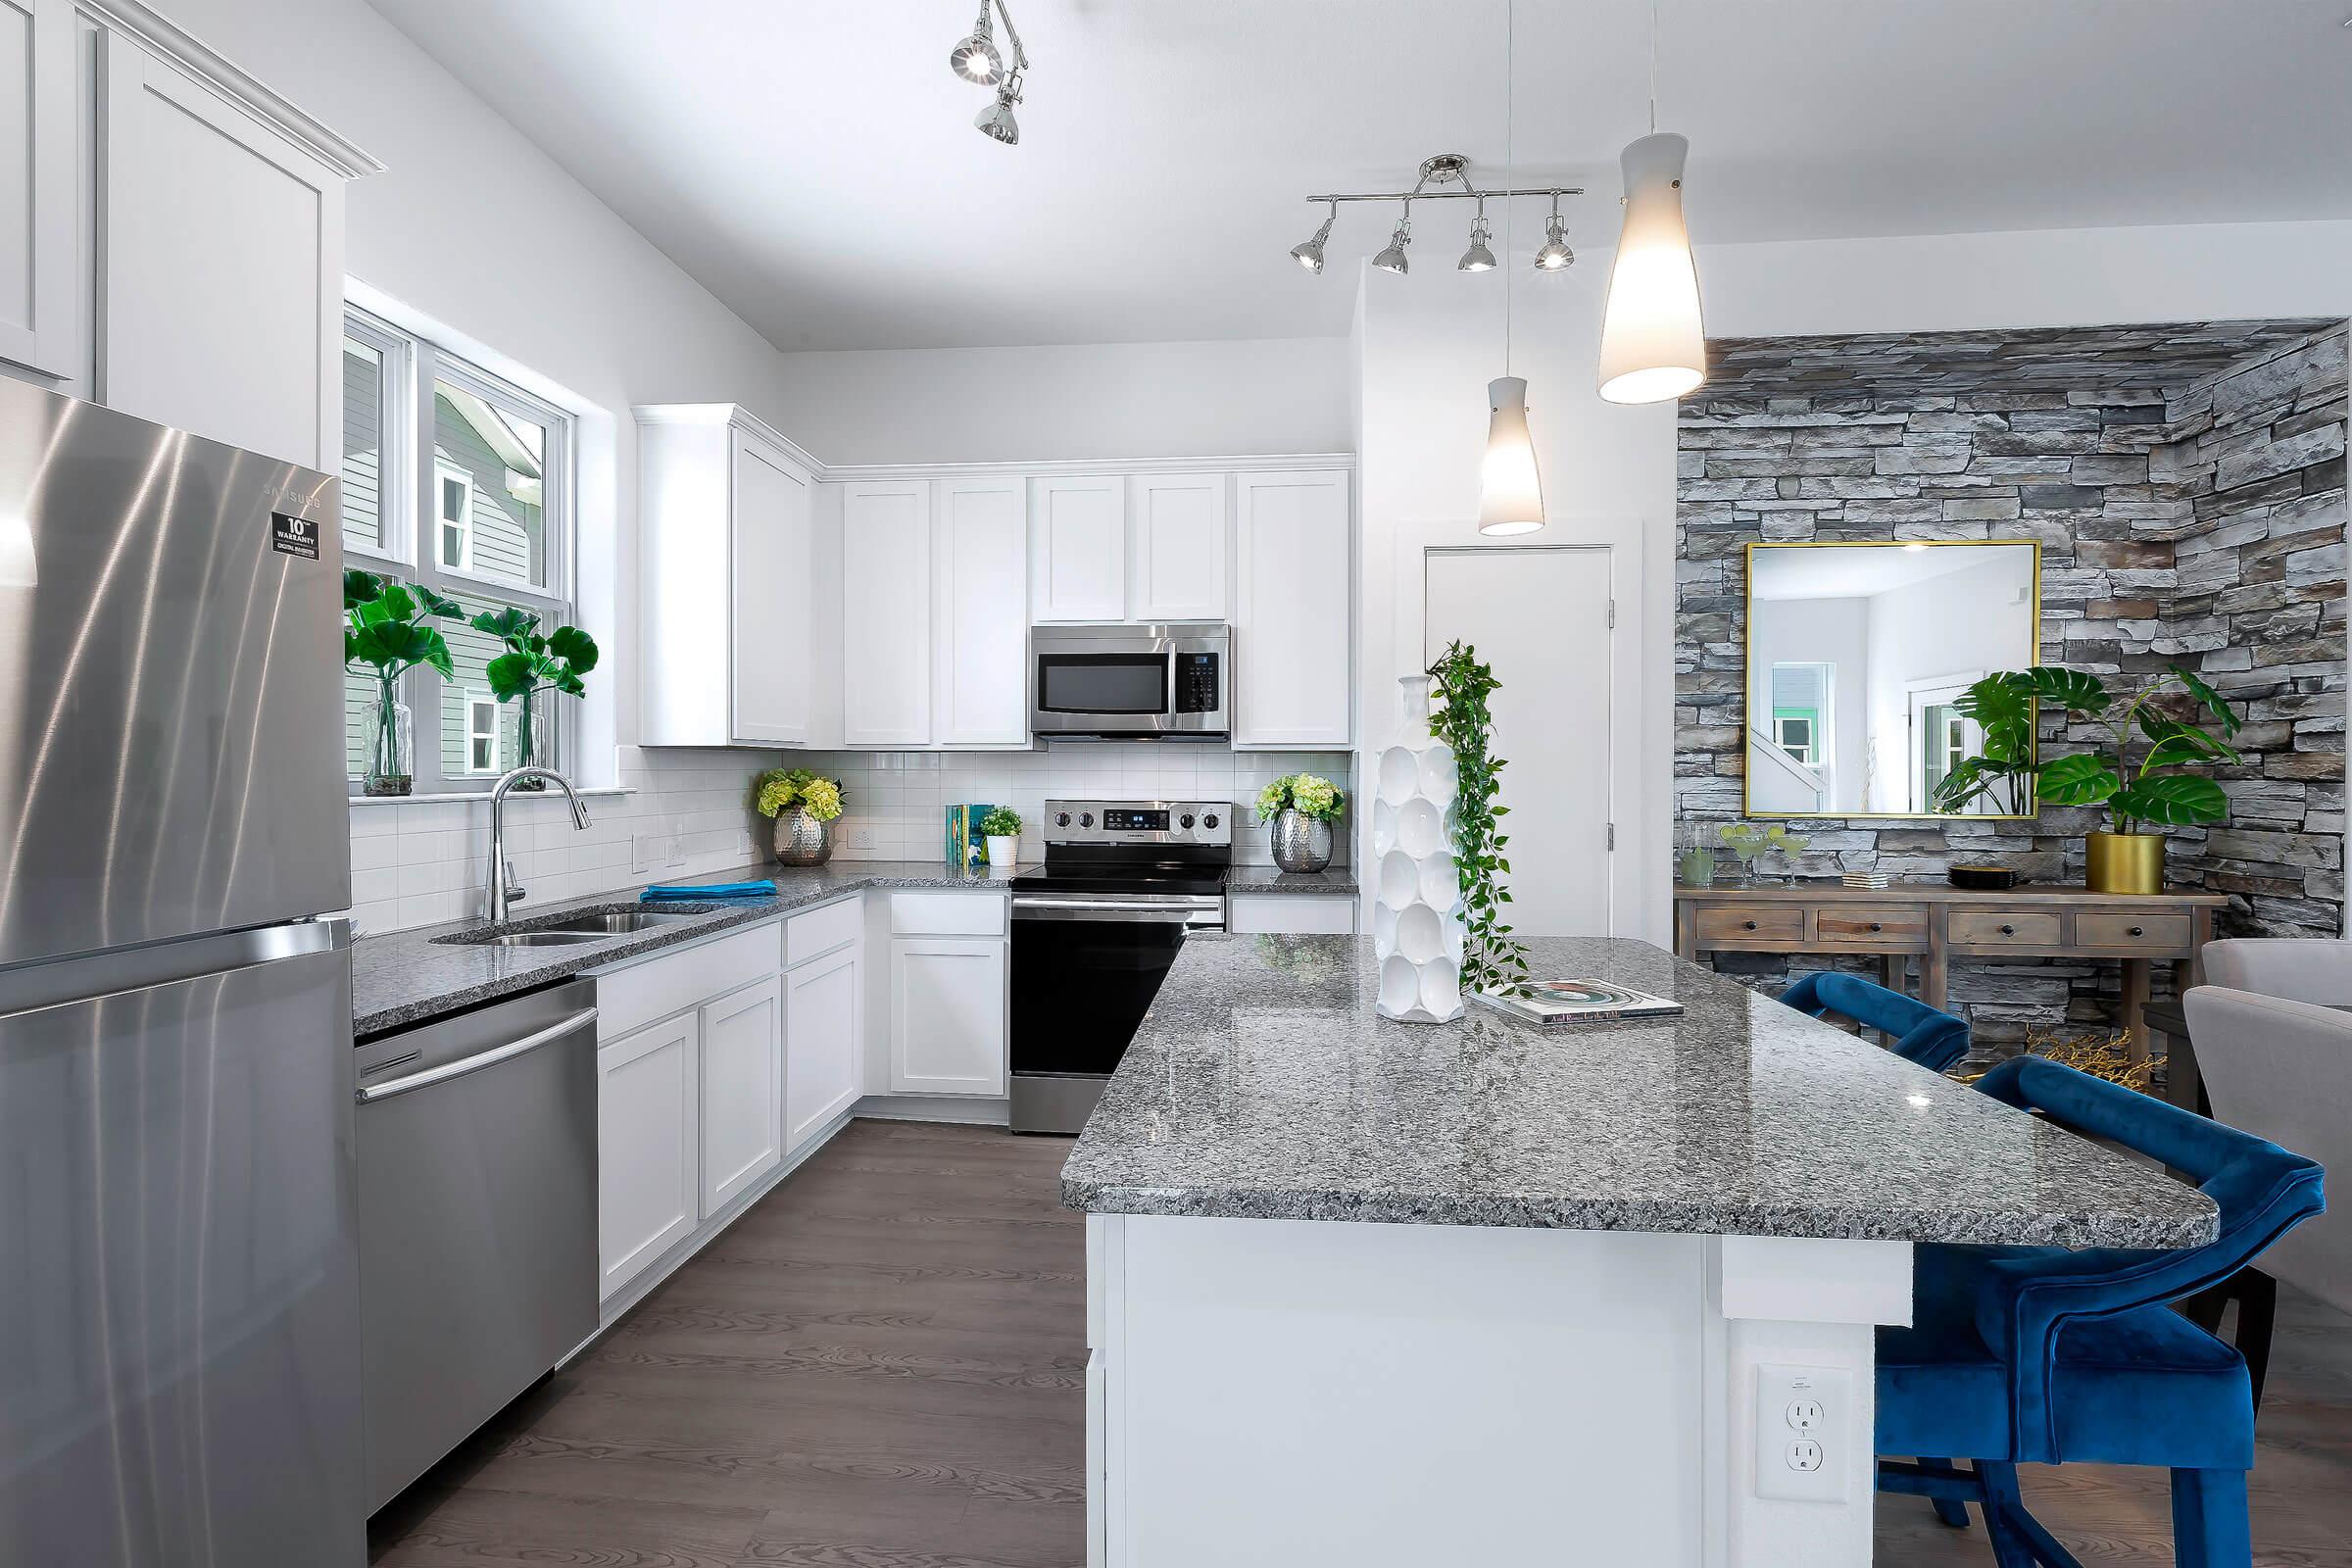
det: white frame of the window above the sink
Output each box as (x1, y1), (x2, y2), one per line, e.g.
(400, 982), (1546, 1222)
(343, 301), (578, 800)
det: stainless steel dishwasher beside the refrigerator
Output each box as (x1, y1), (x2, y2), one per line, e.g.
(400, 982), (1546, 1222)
(358, 980), (598, 1511)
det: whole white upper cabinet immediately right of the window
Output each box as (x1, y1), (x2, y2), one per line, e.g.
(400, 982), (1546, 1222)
(637, 402), (816, 745)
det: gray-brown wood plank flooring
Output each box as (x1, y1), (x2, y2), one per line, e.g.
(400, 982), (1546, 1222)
(369, 1121), (2352, 1568)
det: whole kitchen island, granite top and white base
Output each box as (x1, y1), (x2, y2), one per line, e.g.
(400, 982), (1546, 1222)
(1063, 936), (2216, 1568)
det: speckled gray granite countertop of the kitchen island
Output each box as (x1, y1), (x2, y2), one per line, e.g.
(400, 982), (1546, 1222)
(1060, 936), (2218, 1249)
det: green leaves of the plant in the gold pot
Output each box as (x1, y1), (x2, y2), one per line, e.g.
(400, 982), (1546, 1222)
(1936, 665), (2241, 832)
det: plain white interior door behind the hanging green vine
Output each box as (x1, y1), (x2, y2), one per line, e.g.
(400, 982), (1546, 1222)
(1423, 546), (1616, 938)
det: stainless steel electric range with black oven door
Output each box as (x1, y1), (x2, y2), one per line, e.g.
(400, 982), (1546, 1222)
(1011, 800), (1233, 1133)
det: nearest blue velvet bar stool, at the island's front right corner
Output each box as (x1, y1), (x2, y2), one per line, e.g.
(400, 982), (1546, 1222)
(1877, 1055), (2327, 1568)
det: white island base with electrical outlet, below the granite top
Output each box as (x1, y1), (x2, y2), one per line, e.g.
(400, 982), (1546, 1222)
(1087, 1213), (1912, 1568)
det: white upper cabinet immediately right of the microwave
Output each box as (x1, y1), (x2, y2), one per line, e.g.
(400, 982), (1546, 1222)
(1233, 470), (1354, 748)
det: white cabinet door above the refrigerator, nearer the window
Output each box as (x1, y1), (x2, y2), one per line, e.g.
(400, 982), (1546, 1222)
(96, 37), (343, 472)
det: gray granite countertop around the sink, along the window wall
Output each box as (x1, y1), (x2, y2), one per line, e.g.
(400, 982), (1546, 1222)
(351, 860), (1013, 1037)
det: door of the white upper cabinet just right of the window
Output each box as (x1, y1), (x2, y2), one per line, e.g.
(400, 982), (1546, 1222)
(729, 432), (811, 745)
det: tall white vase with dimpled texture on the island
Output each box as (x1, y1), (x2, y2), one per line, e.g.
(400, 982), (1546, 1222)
(1371, 674), (1463, 1022)
